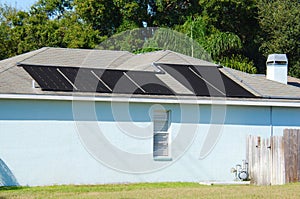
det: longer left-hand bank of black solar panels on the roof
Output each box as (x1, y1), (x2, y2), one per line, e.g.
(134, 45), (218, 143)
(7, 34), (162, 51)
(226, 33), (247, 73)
(23, 65), (173, 95)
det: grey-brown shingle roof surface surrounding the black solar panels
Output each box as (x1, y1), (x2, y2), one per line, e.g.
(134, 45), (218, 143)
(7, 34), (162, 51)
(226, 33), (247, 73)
(0, 47), (300, 99)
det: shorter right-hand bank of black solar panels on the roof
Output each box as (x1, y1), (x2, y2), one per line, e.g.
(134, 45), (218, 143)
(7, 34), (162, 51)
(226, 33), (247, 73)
(160, 64), (255, 97)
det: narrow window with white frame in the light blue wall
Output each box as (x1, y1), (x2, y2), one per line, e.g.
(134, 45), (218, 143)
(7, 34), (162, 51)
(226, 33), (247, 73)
(153, 111), (171, 160)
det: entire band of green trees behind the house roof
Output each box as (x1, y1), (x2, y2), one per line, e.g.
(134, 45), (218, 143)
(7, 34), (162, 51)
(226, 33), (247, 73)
(0, 0), (300, 77)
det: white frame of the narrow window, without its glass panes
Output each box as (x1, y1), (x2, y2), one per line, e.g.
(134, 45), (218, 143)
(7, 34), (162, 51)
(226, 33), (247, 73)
(152, 110), (172, 161)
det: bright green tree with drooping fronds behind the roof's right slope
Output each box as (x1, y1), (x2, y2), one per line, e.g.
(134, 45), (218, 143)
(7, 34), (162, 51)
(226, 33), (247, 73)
(176, 16), (257, 73)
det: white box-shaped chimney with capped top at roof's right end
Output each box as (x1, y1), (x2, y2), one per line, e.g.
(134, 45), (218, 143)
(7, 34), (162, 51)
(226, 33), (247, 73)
(267, 54), (288, 84)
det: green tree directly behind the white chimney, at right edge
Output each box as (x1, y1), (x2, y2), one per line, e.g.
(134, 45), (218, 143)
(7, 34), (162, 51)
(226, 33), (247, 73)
(258, 0), (300, 77)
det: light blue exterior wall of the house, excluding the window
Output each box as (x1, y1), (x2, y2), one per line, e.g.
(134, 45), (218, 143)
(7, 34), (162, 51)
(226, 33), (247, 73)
(0, 100), (300, 186)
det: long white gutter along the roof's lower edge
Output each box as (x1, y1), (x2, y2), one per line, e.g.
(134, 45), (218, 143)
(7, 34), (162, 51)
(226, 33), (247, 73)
(0, 94), (300, 108)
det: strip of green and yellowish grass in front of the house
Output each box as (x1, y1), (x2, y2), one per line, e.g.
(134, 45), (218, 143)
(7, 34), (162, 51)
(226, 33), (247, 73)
(0, 183), (300, 199)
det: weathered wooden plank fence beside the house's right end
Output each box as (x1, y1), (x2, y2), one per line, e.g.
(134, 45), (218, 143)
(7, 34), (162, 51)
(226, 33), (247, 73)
(247, 129), (300, 185)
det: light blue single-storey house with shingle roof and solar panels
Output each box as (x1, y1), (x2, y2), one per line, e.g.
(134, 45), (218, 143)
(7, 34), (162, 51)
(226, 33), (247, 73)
(0, 48), (300, 186)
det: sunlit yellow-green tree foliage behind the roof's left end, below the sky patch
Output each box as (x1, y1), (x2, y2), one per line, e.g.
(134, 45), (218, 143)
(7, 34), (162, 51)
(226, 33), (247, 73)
(0, 0), (102, 59)
